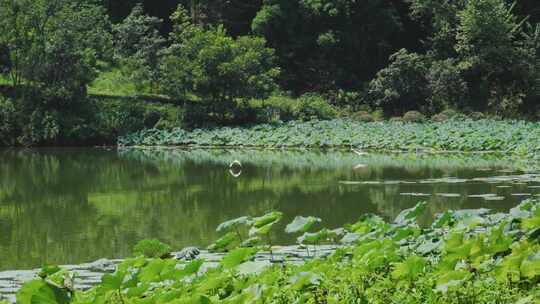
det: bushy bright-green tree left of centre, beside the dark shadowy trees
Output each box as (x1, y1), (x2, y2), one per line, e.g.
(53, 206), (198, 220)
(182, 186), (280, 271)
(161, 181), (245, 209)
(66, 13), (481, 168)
(159, 7), (279, 120)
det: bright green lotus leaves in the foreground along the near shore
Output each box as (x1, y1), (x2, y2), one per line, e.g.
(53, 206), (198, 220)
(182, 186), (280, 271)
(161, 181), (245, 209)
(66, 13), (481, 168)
(12, 200), (540, 304)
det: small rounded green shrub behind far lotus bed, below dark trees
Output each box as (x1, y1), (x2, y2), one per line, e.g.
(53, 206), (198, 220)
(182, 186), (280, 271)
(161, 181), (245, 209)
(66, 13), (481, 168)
(292, 94), (337, 121)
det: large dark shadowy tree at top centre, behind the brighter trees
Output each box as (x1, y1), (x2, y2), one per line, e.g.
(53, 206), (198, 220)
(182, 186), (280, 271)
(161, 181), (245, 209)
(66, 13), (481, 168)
(252, 0), (401, 93)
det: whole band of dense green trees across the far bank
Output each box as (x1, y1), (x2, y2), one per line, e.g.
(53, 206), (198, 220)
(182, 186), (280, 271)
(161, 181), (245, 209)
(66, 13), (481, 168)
(0, 0), (540, 144)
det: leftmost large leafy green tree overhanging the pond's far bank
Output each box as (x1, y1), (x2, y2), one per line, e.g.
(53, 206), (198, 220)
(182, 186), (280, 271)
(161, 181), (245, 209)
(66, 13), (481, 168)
(0, 0), (107, 144)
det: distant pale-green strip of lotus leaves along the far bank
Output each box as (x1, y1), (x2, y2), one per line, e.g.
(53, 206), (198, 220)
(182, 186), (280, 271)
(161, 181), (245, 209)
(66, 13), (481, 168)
(119, 119), (540, 154)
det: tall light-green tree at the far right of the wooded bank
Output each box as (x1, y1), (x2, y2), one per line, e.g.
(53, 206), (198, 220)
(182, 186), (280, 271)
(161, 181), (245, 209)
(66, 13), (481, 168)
(455, 0), (540, 114)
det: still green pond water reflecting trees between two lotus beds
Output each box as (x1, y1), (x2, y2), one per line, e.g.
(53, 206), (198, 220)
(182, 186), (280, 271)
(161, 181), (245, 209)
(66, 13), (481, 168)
(0, 149), (540, 270)
